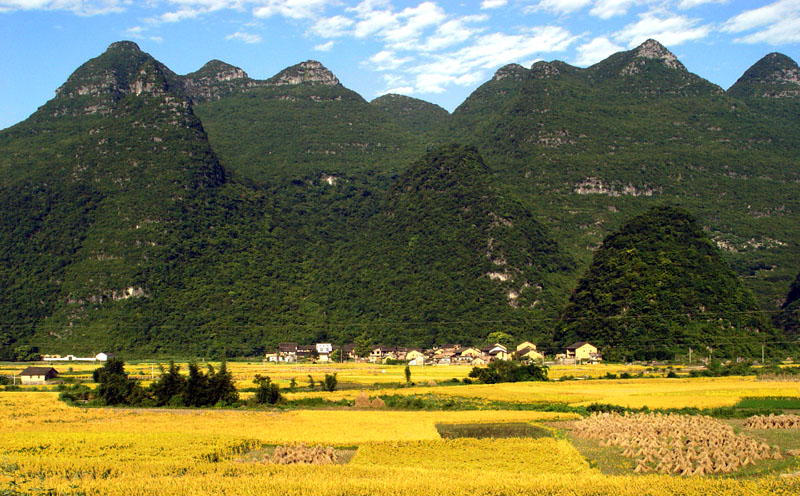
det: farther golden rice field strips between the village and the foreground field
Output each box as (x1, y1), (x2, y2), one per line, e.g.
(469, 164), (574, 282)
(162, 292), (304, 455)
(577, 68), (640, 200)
(0, 362), (800, 409)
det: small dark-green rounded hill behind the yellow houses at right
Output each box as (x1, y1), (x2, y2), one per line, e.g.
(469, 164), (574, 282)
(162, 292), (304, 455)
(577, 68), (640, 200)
(556, 206), (775, 360)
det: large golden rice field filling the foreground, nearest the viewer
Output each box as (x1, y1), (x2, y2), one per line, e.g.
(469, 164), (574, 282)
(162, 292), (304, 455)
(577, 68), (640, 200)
(0, 390), (800, 496)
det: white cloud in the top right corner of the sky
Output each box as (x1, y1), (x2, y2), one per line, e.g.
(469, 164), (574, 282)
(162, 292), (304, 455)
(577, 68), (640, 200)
(722, 0), (800, 45)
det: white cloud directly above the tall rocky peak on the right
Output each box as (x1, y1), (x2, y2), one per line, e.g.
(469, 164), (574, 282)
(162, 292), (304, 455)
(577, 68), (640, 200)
(614, 12), (712, 48)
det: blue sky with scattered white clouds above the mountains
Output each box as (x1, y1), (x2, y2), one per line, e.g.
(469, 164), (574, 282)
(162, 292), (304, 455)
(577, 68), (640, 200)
(0, 0), (800, 128)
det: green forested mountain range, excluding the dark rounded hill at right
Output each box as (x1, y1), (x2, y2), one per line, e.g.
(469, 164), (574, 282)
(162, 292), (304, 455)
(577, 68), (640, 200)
(0, 40), (800, 358)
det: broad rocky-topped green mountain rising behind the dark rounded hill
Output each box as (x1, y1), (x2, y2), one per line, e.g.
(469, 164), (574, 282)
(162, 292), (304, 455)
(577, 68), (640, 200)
(443, 41), (800, 311)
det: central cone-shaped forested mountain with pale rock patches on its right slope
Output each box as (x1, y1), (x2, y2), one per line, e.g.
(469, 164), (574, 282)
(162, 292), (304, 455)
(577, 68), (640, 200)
(306, 144), (573, 345)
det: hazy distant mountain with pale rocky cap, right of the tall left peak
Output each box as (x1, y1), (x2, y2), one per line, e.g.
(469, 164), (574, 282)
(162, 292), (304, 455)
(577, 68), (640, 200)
(195, 61), (430, 181)
